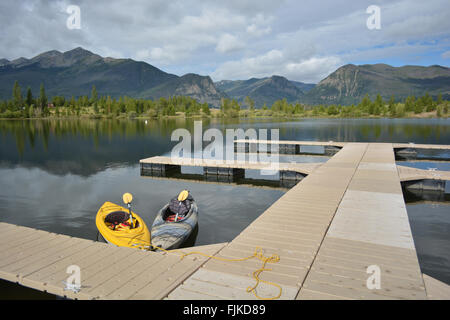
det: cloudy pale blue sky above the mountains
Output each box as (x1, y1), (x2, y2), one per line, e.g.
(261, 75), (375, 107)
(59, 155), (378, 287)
(0, 0), (450, 83)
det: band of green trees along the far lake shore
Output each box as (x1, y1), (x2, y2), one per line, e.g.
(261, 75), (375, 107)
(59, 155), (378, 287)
(0, 81), (449, 118)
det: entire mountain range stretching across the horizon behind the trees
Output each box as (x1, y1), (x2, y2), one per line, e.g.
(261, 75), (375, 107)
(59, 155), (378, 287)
(0, 48), (450, 108)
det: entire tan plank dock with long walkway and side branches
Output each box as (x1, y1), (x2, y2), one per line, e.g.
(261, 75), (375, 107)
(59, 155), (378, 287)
(0, 142), (450, 300)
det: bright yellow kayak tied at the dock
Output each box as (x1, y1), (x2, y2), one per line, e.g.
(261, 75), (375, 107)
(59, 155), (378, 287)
(95, 202), (150, 249)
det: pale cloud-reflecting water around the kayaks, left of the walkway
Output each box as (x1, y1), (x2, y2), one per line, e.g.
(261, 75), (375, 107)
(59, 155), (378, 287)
(0, 165), (284, 245)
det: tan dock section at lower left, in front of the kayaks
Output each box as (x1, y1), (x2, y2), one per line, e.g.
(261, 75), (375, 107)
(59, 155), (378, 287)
(0, 223), (229, 300)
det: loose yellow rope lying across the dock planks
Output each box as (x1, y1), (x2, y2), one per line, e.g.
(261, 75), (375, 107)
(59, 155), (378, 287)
(135, 245), (283, 300)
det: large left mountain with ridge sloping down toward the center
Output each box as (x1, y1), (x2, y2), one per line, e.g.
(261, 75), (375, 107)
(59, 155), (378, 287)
(0, 48), (223, 105)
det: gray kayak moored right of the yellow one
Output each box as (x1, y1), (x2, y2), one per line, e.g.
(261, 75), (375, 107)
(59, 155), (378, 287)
(151, 201), (198, 250)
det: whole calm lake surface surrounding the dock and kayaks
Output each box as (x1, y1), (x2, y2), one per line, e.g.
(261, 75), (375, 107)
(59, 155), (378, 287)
(0, 119), (450, 298)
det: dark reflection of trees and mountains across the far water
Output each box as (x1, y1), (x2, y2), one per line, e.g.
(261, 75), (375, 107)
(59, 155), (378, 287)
(0, 118), (450, 175)
